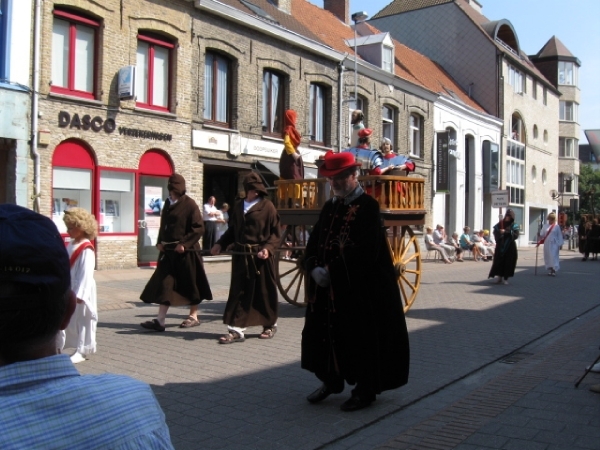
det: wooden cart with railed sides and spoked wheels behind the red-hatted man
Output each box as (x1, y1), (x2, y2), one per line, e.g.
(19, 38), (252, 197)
(274, 175), (425, 312)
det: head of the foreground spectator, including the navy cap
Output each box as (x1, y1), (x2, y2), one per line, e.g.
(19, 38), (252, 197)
(0, 204), (76, 365)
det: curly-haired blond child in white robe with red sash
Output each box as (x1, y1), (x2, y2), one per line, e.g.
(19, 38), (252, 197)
(61, 208), (98, 364)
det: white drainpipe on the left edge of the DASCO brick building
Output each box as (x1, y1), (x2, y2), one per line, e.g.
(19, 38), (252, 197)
(31, 0), (42, 213)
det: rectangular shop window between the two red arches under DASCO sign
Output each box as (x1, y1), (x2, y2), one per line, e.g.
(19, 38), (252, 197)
(98, 169), (135, 233)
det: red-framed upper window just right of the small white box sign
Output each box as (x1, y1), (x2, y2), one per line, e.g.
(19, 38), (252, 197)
(136, 34), (175, 112)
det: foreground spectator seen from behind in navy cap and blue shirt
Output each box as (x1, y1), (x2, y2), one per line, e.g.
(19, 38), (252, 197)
(0, 204), (173, 449)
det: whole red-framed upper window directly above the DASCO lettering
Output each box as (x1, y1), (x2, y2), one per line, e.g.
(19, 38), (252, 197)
(50, 10), (100, 99)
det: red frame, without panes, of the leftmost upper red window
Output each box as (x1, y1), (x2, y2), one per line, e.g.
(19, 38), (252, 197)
(50, 9), (100, 100)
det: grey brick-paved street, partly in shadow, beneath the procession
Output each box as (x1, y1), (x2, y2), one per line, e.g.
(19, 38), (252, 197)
(77, 249), (600, 450)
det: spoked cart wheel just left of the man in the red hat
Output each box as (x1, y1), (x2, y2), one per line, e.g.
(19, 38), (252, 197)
(275, 247), (306, 306)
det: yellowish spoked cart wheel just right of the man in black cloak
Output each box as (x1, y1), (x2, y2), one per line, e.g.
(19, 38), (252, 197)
(388, 226), (421, 313)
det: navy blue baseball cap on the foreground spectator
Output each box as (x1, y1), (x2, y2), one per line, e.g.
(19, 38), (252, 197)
(0, 204), (71, 298)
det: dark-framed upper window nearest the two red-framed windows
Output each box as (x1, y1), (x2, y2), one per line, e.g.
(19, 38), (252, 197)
(204, 52), (231, 126)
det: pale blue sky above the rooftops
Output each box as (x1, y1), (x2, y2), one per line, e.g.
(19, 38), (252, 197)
(309, 0), (600, 144)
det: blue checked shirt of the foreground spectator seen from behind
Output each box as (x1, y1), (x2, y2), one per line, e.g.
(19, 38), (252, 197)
(0, 355), (173, 450)
